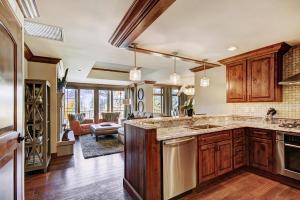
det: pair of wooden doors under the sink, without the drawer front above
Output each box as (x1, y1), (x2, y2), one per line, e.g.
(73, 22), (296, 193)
(199, 139), (233, 183)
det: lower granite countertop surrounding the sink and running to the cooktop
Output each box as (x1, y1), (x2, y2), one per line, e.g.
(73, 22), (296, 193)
(157, 121), (300, 141)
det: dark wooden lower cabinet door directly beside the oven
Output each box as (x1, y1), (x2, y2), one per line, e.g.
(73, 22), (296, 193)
(249, 137), (273, 172)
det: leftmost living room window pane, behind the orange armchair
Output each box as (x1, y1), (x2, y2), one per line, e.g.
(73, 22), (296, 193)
(64, 89), (77, 121)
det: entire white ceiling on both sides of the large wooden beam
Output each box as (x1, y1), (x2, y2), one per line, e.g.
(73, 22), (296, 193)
(25, 0), (300, 85)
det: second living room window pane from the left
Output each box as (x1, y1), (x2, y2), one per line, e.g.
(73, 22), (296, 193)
(80, 89), (94, 119)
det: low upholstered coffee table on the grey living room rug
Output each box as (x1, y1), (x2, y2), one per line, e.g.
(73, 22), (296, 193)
(91, 122), (122, 141)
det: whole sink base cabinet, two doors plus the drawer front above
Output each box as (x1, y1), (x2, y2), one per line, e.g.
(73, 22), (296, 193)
(198, 131), (233, 183)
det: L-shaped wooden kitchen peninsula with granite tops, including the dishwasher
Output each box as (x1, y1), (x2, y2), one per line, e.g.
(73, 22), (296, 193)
(123, 116), (300, 200)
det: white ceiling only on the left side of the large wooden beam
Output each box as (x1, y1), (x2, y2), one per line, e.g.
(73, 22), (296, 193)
(25, 0), (196, 85)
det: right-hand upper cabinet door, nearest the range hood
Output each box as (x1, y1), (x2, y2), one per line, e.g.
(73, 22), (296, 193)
(247, 54), (277, 102)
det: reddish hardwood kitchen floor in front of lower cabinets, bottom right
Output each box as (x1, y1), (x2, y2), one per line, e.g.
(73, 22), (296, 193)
(182, 172), (300, 200)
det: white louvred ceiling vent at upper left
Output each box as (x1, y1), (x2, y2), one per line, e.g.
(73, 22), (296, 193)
(24, 21), (64, 41)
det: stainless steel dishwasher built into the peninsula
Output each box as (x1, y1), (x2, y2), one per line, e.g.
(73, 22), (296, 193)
(163, 137), (197, 200)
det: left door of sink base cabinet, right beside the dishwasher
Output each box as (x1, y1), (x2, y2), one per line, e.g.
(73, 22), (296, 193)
(199, 143), (217, 183)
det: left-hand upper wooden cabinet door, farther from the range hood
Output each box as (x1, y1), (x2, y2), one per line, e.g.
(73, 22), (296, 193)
(226, 61), (247, 103)
